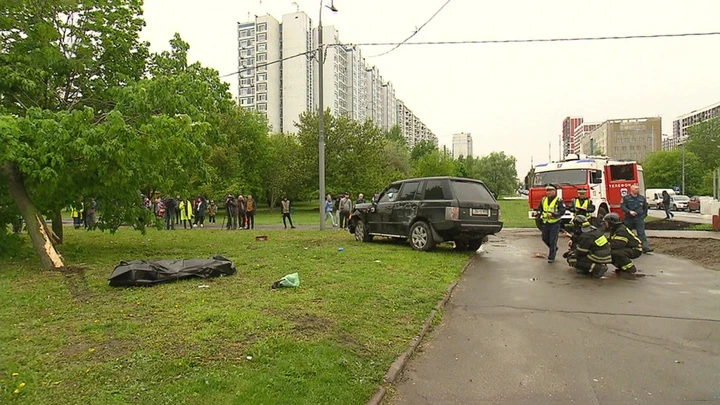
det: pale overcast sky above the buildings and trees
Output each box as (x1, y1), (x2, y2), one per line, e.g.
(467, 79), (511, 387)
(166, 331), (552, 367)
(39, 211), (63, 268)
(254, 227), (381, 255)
(142, 0), (720, 178)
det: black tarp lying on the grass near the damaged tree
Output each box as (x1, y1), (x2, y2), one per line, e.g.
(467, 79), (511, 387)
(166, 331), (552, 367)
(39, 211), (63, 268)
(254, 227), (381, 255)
(109, 255), (236, 287)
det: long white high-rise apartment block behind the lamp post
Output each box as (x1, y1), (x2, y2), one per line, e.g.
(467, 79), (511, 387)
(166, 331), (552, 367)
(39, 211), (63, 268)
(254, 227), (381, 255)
(238, 11), (432, 139)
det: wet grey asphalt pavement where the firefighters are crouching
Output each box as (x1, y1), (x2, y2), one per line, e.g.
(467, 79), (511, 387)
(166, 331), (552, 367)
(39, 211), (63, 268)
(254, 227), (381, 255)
(386, 231), (720, 405)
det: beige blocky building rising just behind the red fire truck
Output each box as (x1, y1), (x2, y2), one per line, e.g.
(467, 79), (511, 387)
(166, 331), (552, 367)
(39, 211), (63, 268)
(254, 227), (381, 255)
(580, 117), (662, 162)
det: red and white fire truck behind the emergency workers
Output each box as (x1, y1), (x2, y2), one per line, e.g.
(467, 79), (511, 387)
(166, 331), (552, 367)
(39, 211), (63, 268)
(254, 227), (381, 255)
(528, 154), (645, 228)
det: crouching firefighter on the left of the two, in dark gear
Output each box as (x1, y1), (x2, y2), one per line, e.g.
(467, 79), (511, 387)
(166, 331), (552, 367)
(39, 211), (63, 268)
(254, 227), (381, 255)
(567, 215), (612, 278)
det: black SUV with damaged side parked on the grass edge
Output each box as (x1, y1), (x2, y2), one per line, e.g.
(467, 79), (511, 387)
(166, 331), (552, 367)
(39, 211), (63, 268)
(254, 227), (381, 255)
(349, 177), (502, 250)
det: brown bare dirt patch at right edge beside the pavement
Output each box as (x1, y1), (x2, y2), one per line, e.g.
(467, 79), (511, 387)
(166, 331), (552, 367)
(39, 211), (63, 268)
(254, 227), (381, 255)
(650, 235), (720, 271)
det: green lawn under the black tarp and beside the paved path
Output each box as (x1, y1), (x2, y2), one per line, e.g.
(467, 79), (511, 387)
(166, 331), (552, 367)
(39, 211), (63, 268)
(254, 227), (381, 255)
(0, 224), (470, 404)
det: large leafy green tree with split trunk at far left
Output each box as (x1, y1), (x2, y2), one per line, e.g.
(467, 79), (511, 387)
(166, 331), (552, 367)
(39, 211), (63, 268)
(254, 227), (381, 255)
(0, 0), (232, 269)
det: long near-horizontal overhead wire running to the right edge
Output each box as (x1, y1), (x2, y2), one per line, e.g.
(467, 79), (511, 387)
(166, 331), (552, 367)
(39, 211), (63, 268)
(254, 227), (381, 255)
(344, 32), (720, 46)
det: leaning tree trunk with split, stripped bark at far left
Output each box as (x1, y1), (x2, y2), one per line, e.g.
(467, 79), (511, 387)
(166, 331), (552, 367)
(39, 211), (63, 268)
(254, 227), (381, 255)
(2, 162), (65, 270)
